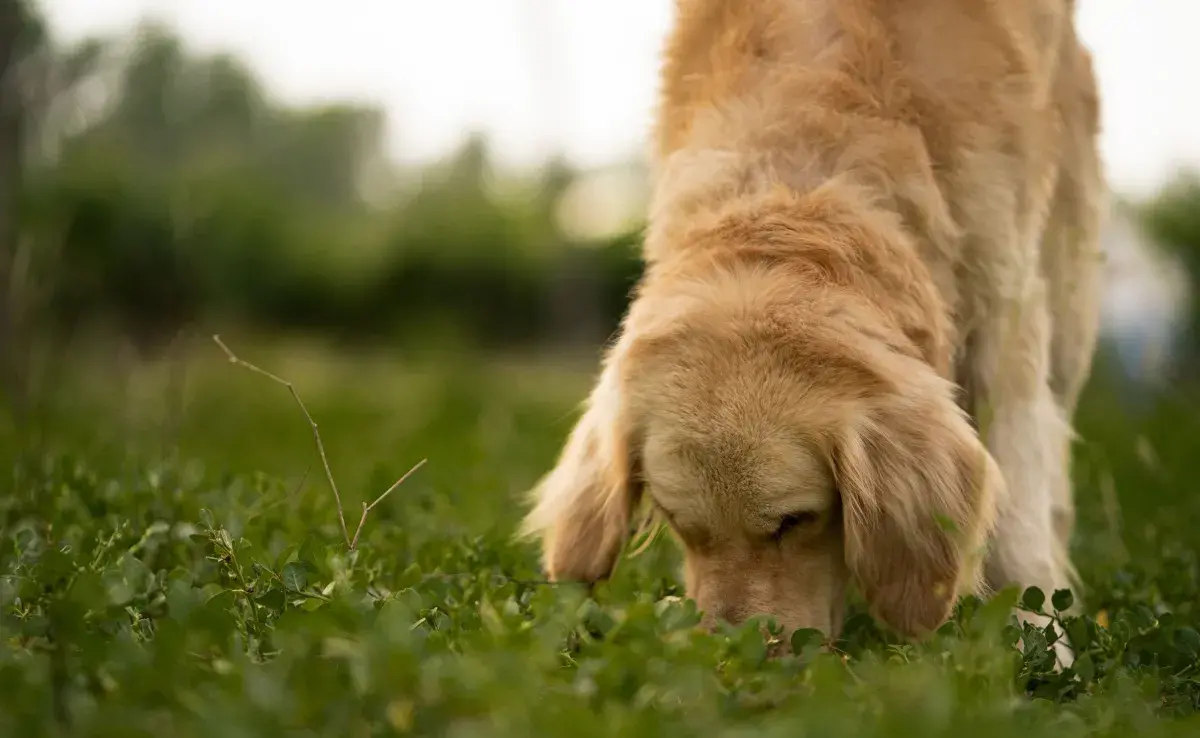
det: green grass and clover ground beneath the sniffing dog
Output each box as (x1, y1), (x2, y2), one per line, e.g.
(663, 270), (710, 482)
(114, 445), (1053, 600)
(0, 340), (1200, 738)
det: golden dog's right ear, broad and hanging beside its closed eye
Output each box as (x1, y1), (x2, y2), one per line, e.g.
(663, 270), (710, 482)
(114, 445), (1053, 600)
(833, 367), (1003, 636)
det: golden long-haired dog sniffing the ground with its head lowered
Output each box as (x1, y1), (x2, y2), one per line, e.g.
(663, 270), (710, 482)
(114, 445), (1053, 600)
(522, 0), (1108, 662)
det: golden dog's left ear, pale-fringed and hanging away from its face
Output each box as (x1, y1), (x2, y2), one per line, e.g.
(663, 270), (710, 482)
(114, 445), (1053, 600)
(522, 356), (641, 583)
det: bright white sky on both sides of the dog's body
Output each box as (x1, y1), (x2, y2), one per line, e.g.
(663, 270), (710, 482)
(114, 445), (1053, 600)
(42, 0), (1200, 194)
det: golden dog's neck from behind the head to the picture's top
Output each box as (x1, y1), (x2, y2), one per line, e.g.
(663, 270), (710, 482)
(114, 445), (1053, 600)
(644, 0), (961, 376)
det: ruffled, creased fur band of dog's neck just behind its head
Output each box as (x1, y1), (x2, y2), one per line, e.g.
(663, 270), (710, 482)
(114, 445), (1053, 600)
(643, 151), (954, 377)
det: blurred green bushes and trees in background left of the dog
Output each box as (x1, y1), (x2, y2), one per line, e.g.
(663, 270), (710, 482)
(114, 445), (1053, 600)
(9, 16), (641, 350)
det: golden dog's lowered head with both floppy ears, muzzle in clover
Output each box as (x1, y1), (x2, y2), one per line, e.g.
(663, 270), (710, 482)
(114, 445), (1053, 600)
(526, 264), (1001, 636)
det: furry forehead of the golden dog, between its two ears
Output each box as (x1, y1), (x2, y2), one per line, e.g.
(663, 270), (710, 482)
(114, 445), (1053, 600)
(631, 321), (838, 518)
